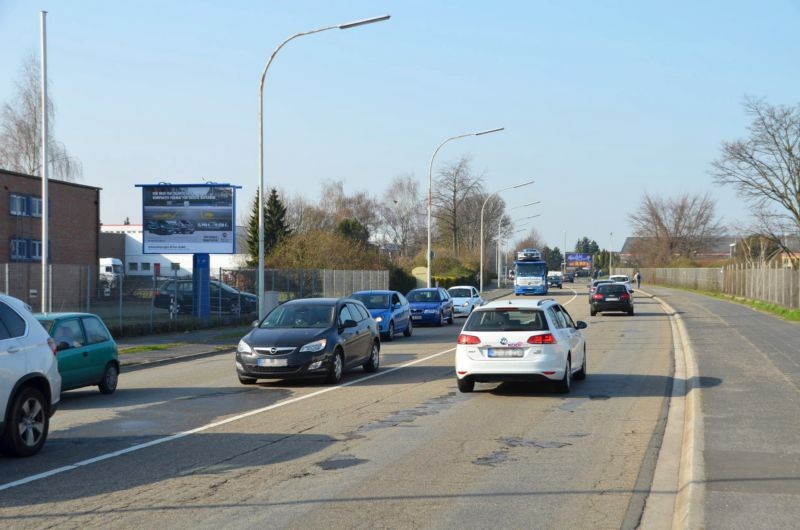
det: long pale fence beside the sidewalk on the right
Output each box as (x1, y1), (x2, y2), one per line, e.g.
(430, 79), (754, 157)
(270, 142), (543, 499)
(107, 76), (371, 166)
(613, 264), (800, 309)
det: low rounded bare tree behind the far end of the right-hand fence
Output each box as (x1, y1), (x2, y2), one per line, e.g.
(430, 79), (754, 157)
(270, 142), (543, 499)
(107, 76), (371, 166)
(628, 193), (723, 265)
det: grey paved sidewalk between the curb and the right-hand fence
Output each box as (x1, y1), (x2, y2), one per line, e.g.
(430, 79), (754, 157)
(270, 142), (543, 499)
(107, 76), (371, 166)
(648, 288), (800, 529)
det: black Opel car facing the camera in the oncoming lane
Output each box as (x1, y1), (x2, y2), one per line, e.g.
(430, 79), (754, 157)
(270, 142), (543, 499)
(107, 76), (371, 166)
(236, 298), (381, 385)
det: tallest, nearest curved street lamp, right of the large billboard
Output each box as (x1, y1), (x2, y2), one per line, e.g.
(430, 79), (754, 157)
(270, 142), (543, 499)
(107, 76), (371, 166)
(256, 15), (390, 320)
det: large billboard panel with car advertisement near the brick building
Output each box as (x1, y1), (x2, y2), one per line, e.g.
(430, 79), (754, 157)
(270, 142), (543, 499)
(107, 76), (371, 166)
(137, 183), (236, 254)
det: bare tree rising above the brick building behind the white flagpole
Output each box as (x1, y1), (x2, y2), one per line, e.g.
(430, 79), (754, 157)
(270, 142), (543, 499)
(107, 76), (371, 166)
(0, 56), (82, 181)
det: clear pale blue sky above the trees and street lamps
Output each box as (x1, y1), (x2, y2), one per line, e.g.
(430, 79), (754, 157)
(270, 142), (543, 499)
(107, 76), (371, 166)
(0, 0), (800, 249)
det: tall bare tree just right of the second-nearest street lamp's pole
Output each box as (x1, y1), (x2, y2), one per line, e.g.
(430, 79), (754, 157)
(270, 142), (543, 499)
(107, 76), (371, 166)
(432, 156), (483, 256)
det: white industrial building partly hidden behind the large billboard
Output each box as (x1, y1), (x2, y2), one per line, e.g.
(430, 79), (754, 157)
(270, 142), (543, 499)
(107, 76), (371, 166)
(100, 224), (247, 277)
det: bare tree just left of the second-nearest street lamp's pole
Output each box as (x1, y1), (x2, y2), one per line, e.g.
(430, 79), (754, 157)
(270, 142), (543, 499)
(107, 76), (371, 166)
(381, 175), (425, 256)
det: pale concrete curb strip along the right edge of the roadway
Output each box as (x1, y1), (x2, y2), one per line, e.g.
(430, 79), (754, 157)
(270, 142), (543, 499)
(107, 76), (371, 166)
(639, 290), (705, 528)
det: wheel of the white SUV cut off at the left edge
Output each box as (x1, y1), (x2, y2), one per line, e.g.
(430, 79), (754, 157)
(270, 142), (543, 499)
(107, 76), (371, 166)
(0, 386), (50, 456)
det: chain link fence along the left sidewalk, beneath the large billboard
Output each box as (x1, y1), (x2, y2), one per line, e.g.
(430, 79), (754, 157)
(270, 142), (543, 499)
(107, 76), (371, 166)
(0, 263), (389, 337)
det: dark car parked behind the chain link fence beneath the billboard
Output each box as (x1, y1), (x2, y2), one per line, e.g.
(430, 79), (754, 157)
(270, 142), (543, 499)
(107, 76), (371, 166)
(153, 279), (258, 315)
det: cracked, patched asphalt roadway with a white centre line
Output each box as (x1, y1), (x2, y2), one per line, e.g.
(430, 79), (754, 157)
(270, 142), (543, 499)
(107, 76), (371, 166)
(0, 284), (673, 528)
